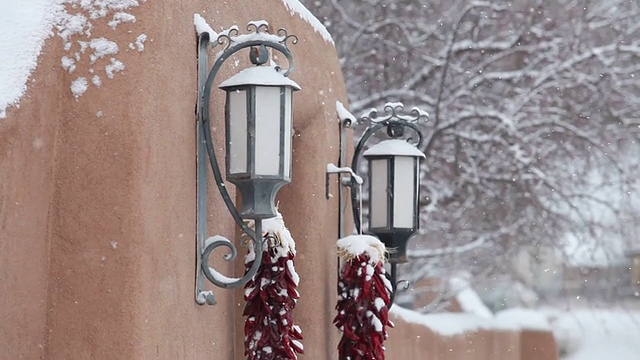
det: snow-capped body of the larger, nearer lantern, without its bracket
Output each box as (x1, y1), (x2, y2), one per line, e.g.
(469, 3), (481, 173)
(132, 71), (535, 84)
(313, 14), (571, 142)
(220, 63), (300, 219)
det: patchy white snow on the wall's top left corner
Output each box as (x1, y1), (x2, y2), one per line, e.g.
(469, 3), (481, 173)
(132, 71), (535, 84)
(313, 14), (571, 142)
(0, 0), (147, 118)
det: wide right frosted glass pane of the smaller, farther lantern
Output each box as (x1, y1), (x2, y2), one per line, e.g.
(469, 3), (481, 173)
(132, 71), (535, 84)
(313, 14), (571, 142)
(393, 156), (416, 229)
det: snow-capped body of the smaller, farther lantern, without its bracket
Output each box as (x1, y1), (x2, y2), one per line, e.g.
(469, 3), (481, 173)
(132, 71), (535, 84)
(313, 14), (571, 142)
(362, 139), (425, 263)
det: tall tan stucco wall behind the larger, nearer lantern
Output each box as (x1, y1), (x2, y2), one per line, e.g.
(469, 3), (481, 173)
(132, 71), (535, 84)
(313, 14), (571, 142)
(0, 0), (346, 359)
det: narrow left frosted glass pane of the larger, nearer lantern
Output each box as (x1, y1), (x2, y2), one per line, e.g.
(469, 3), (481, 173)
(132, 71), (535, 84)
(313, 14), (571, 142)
(227, 90), (247, 174)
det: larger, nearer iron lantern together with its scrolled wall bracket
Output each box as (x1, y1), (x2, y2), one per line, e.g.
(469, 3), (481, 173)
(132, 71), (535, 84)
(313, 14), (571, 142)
(195, 17), (300, 305)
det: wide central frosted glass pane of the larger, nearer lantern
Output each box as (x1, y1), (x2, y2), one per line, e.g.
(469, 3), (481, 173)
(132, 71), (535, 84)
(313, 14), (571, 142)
(255, 86), (280, 175)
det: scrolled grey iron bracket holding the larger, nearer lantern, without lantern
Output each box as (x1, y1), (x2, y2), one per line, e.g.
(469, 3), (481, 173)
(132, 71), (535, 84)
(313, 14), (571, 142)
(195, 21), (298, 305)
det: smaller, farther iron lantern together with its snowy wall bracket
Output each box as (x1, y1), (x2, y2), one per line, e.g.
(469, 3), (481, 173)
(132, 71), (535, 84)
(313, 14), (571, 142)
(327, 103), (429, 304)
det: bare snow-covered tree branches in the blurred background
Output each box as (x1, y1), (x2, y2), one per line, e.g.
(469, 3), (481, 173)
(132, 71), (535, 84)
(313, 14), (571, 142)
(305, 0), (640, 296)
